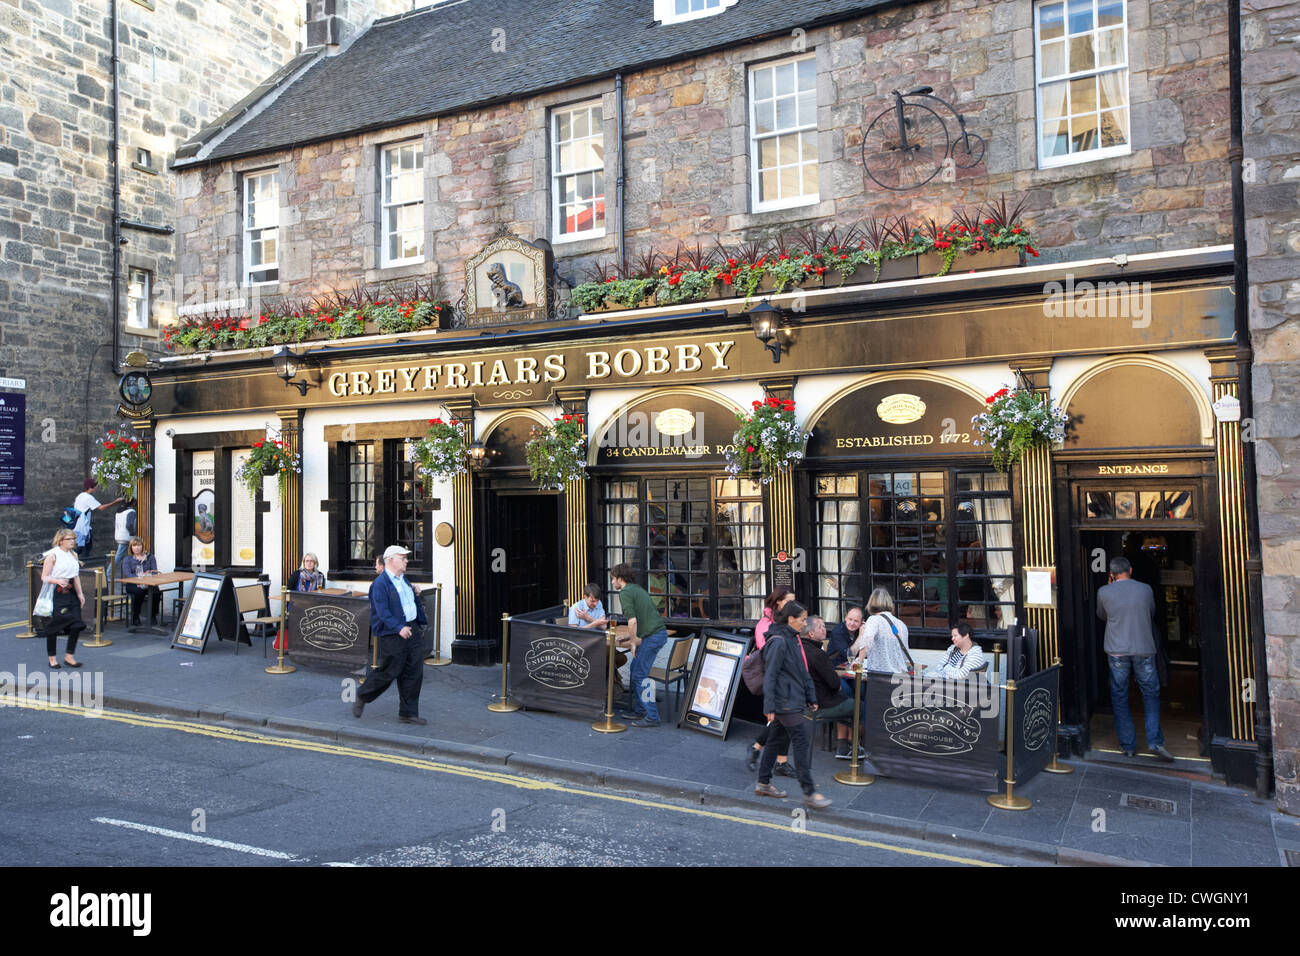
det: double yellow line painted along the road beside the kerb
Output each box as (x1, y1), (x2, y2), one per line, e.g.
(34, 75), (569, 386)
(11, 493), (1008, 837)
(10, 700), (1000, 866)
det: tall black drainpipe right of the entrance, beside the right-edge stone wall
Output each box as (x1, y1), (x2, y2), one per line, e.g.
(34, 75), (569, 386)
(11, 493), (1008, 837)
(1227, 0), (1273, 799)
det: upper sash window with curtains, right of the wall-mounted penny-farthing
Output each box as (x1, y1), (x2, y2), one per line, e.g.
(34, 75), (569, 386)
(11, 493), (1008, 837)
(1034, 0), (1131, 166)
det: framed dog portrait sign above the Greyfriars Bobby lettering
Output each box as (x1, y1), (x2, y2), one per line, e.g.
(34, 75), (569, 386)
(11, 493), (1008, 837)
(465, 235), (553, 328)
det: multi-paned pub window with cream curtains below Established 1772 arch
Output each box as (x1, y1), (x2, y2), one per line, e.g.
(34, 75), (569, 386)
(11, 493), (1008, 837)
(815, 468), (1015, 640)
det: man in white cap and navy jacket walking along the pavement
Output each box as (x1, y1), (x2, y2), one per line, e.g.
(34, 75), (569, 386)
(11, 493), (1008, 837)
(352, 545), (429, 726)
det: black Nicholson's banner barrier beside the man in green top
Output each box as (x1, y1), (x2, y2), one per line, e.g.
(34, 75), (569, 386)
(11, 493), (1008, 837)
(508, 606), (608, 718)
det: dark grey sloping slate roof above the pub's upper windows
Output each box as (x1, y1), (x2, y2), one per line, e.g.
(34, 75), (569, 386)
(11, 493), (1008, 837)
(177, 0), (897, 165)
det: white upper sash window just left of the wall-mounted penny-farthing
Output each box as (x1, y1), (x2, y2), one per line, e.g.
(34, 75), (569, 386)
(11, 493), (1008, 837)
(749, 56), (818, 211)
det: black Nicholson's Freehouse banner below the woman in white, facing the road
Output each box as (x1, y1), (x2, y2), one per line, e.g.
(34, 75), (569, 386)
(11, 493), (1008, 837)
(863, 674), (1006, 793)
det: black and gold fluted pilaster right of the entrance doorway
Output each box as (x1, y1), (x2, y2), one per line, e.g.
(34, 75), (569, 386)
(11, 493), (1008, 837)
(1209, 349), (1256, 740)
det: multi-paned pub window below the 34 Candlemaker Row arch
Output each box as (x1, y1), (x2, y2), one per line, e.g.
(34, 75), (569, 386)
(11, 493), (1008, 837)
(598, 476), (767, 622)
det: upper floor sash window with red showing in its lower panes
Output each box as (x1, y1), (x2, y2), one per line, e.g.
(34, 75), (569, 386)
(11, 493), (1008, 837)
(551, 103), (605, 242)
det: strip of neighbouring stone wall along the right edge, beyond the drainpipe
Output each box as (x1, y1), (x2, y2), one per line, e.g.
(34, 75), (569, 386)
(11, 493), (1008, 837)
(1242, 0), (1300, 814)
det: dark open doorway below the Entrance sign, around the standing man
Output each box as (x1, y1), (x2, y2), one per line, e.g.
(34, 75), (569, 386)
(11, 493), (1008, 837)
(1079, 524), (1208, 757)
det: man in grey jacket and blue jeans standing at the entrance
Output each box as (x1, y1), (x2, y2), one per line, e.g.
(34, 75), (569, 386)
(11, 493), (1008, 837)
(1097, 558), (1174, 762)
